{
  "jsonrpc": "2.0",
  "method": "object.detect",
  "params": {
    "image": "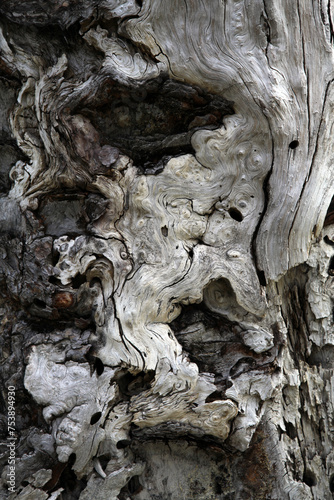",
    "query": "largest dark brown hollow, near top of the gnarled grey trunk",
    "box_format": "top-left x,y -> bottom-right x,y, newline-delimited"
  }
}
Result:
77,77 -> 234,173
